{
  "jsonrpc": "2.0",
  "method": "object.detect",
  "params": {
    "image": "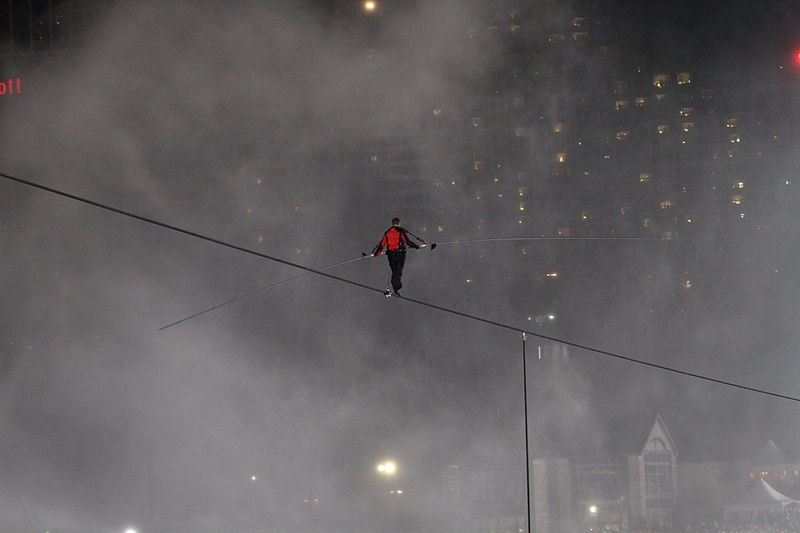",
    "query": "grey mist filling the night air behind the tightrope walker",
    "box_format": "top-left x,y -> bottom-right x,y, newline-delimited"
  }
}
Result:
0,0 -> 800,533
